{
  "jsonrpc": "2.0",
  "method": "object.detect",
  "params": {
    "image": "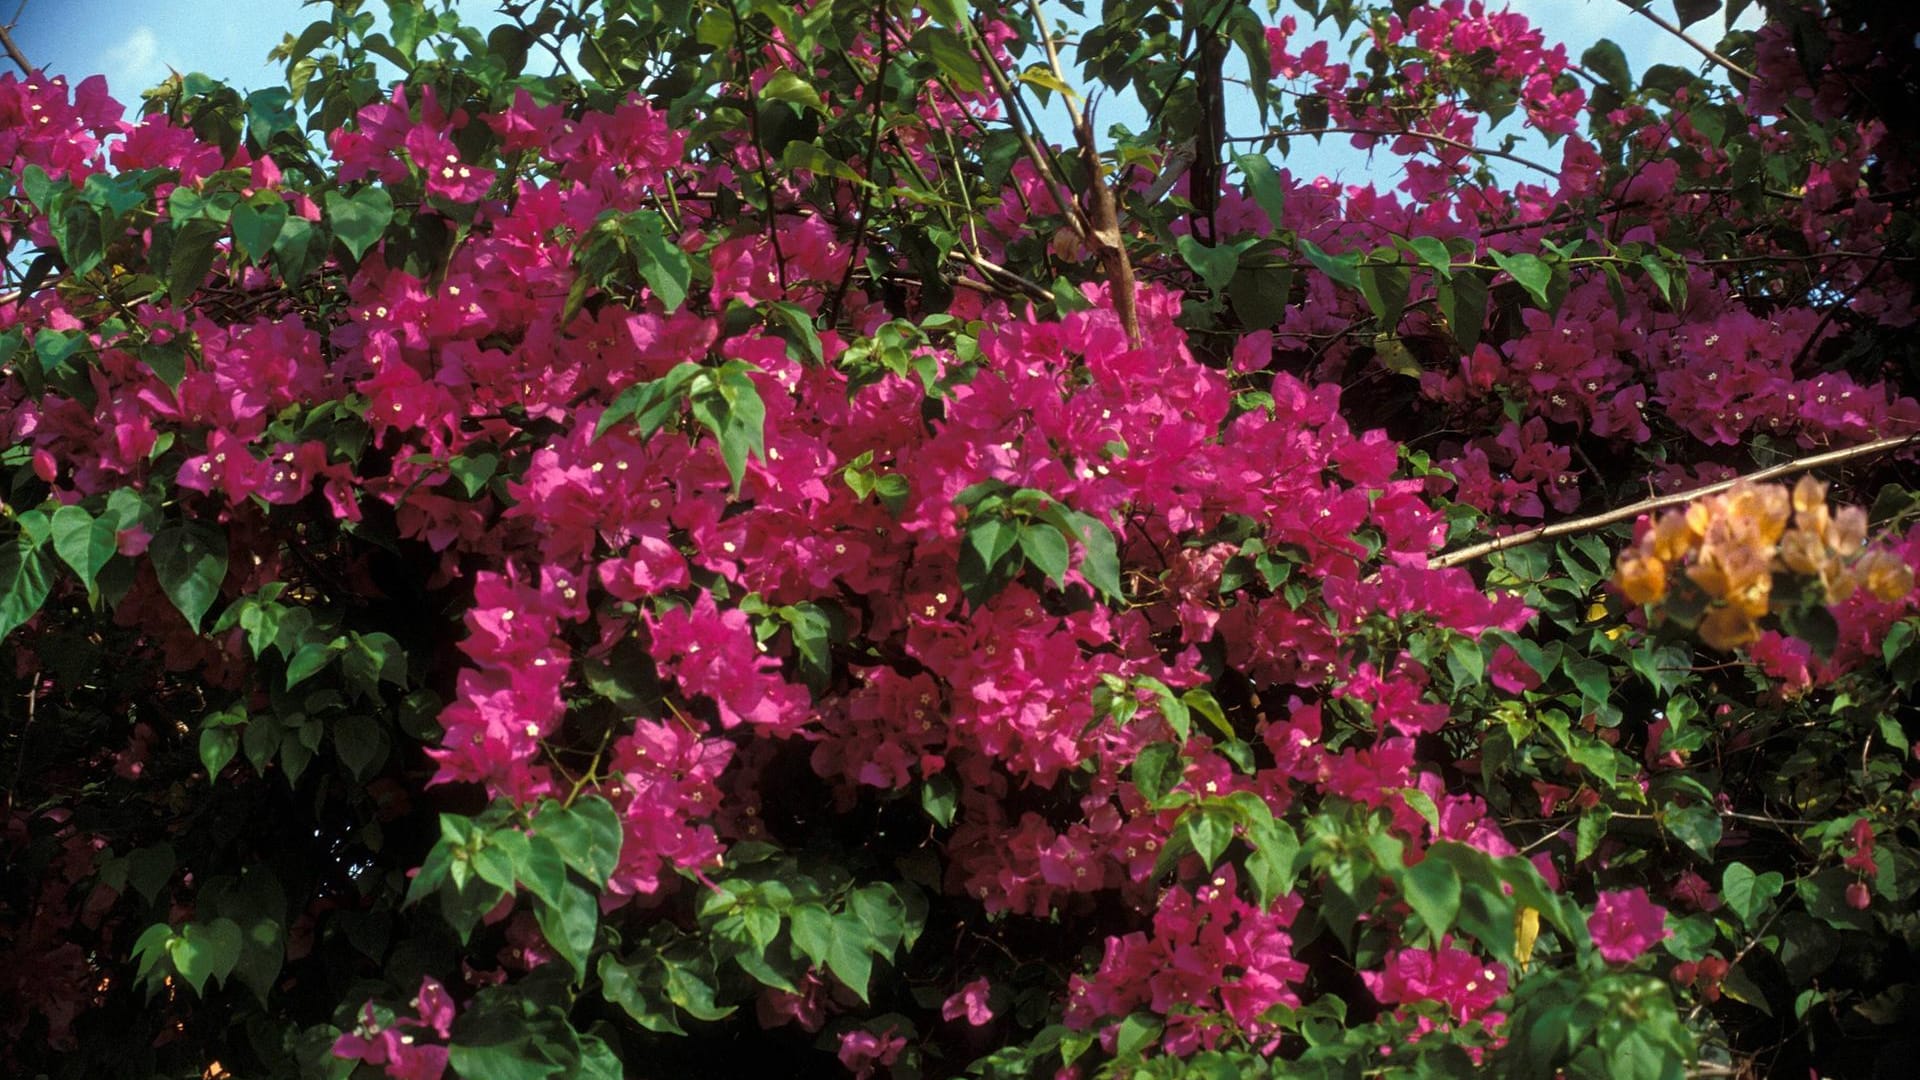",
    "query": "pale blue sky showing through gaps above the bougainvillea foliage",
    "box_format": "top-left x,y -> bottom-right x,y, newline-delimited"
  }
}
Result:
15,0 -> 1753,186
